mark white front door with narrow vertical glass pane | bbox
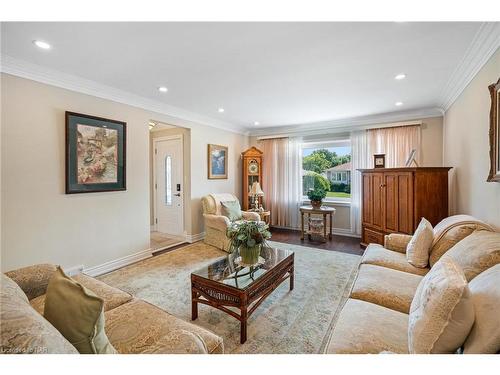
[153,136,184,236]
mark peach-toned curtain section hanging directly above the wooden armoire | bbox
[368,125,421,168]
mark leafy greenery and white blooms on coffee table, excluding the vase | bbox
[226,221,271,252]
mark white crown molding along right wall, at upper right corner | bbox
[439,22,500,111]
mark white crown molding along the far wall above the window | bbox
[250,108,444,137]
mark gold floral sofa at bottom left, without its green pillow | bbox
[0,264,224,354]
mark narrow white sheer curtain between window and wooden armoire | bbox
[351,130,373,235]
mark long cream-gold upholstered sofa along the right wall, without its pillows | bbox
[326,215,500,354]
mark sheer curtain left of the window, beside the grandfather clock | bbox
[259,138,302,228]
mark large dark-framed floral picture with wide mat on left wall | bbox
[65,111,127,194]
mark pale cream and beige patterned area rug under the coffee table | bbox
[99,242,360,354]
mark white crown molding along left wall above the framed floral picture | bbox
[0,55,248,135]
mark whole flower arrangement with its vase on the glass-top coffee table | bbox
[226,221,271,265]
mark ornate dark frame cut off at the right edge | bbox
[486,78,500,182]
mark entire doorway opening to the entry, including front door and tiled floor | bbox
[150,125,185,252]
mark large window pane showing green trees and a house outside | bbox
[302,140,351,201]
